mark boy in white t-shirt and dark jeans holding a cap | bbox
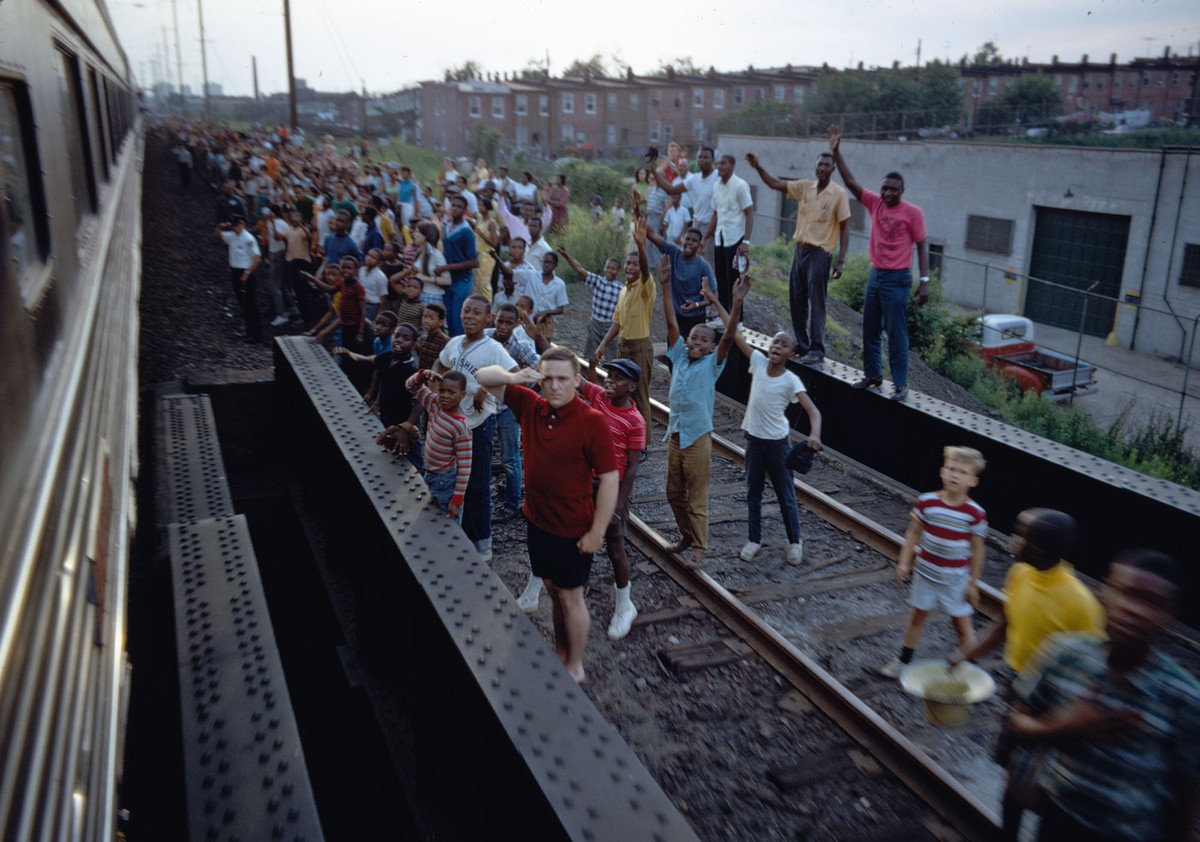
[734,319,821,565]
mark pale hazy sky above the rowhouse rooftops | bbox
[108,0,1200,95]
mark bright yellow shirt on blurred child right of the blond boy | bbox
[1004,561,1104,672]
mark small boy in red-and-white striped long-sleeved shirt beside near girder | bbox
[404,368,472,523]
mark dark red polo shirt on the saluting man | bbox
[504,386,617,539]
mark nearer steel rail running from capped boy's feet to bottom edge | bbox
[629,515,1000,841]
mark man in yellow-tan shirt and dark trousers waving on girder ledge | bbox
[746,152,850,366]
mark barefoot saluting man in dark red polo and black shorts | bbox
[475,347,619,684]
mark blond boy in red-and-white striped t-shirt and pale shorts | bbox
[880,445,988,678]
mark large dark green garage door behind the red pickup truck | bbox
[1025,208,1129,336]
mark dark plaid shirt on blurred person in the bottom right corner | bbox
[1013,632,1200,840]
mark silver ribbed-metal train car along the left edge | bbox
[0,0,142,840]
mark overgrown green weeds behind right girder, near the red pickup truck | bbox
[830,257,1200,489]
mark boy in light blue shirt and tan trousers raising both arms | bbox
[659,260,750,569]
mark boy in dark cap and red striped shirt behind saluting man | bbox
[517,359,646,640]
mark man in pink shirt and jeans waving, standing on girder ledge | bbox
[829,126,929,401]
